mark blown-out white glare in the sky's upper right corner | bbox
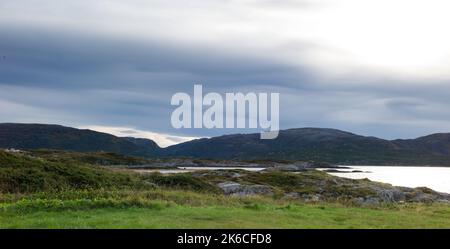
[304,0,450,79]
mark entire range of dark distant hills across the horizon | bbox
[0,123,450,166]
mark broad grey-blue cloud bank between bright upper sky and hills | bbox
[0,4,450,141]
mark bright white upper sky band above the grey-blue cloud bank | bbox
[0,0,450,80]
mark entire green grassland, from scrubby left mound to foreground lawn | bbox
[0,151,450,228]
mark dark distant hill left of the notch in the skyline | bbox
[0,123,160,157]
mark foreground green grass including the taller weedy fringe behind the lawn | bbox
[0,190,450,228]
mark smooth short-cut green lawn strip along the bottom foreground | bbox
[0,199,450,228]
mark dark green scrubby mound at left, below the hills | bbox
[0,151,145,193]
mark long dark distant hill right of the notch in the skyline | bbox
[163,128,450,165]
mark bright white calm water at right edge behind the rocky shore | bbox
[330,166,450,193]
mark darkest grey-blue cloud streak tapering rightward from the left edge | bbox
[0,27,304,89]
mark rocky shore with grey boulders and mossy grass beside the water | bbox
[192,167,450,205]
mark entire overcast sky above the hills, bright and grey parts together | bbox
[0,0,450,146]
